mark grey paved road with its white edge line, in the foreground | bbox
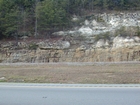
[0,83,140,105]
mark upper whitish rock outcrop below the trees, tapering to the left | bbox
[54,12,140,37]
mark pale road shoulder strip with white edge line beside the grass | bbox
[0,83,140,88]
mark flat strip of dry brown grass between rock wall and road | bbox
[0,64,140,84]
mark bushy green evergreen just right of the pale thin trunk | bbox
[37,0,68,34]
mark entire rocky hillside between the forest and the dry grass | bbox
[0,12,140,63]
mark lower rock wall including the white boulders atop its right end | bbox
[0,36,140,63]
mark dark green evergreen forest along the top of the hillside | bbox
[0,0,140,39]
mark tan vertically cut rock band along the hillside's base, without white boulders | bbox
[0,46,140,63]
